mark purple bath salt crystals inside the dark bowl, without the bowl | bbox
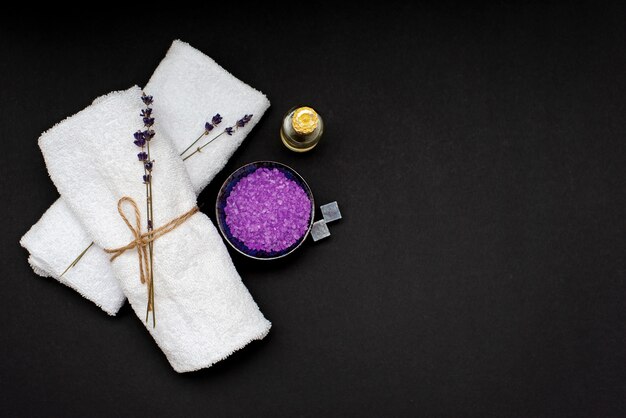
[224,168,311,252]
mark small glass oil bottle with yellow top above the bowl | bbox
[280,106,324,152]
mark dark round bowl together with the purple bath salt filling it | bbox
[216,161,315,260]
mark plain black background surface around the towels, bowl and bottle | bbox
[0,3,626,417]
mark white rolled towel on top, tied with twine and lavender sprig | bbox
[39,87,271,372]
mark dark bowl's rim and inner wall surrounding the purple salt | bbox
[215,161,315,260]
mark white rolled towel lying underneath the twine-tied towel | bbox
[20,41,269,315]
